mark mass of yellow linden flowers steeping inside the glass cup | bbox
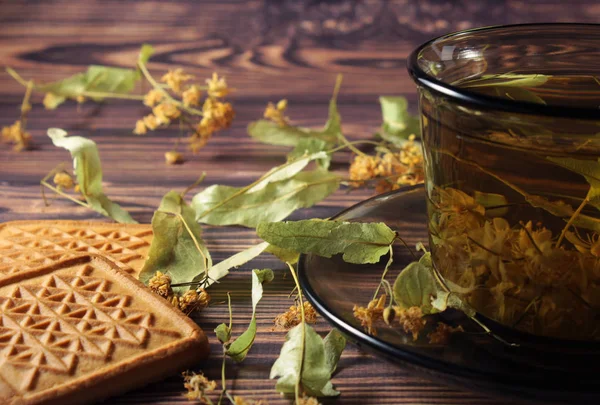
[429,187,600,339]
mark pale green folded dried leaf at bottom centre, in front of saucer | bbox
[270,323,346,397]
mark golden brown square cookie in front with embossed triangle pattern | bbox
[0,255,208,404]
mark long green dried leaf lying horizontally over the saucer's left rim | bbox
[256,219,396,263]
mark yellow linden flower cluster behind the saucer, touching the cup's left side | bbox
[349,135,425,193]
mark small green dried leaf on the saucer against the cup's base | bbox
[393,253,438,315]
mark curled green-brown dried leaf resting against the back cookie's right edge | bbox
[139,191,212,292]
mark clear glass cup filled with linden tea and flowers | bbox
[408,24,600,340]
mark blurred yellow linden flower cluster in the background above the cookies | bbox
[133,68,235,159]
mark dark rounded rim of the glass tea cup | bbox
[406,23,600,120]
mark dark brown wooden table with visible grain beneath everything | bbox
[0,0,600,404]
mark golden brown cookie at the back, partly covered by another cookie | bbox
[0,220,152,279]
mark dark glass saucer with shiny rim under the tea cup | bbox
[298,185,600,404]
